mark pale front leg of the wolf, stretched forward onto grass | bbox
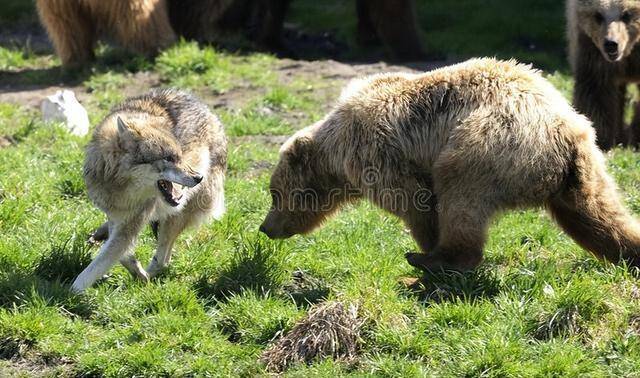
[71,216,144,293]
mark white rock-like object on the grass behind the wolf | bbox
[40,89,89,136]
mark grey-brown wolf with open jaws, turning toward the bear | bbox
[71,89,227,292]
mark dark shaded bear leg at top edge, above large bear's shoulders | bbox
[356,0,426,61]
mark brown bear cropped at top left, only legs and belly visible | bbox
[36,0,176,67]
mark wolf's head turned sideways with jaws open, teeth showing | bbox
[116,116,202,207]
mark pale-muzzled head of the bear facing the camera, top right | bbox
[576,0,640,62]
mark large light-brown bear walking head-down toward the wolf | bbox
[260,59,640,270]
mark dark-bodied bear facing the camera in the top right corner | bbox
[567,0,640,150]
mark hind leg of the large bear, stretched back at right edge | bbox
[547,128,640,266]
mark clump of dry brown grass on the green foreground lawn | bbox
[260,302,363,372]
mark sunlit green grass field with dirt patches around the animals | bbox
[0,0,640,377]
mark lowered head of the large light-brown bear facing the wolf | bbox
[260,126,344,239]
